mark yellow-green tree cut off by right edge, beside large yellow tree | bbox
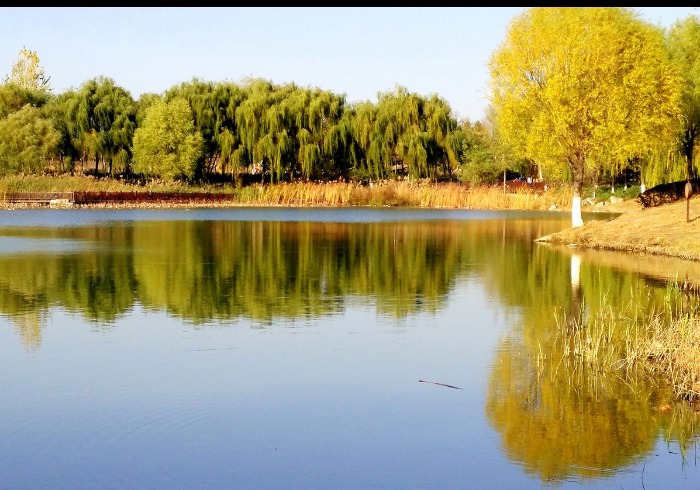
[667,15,700,184]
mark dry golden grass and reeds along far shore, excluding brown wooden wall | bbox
[0,176,572,210]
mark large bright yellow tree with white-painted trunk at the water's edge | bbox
[489,7,681,227]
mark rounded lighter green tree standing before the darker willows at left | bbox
[133,97,204,180]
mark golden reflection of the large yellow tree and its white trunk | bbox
[486,247,697,483]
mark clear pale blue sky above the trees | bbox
[0,7,700,121]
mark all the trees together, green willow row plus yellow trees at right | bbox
[5,7,700,196]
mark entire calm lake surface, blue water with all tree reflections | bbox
[0,208,700,490]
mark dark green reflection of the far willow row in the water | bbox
[0,212,572,324]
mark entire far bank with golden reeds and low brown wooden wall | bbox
[0,176,634,213]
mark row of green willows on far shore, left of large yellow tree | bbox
[0,71,512,188]
